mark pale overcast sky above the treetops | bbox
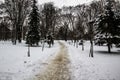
[0,0,92,7]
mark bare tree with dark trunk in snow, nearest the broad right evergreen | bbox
[87,2,99,57]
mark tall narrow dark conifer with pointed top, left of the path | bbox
[26,0,40,46]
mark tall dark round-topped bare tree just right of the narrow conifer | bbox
[42,2,56,38]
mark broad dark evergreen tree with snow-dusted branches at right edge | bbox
[98,0,120,53]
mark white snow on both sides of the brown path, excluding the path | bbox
[0,41,120,80]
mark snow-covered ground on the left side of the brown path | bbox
[0,42,59,80]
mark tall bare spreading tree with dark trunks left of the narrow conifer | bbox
[5,0,31,44]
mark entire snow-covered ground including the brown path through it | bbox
[0,41,120,80]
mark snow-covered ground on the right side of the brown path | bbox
[66,41,120,80]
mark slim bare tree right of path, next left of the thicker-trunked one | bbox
[76,4,87,50]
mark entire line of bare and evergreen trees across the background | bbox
[1,0,120,57]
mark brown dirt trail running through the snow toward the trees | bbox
[34,42,70,80]
